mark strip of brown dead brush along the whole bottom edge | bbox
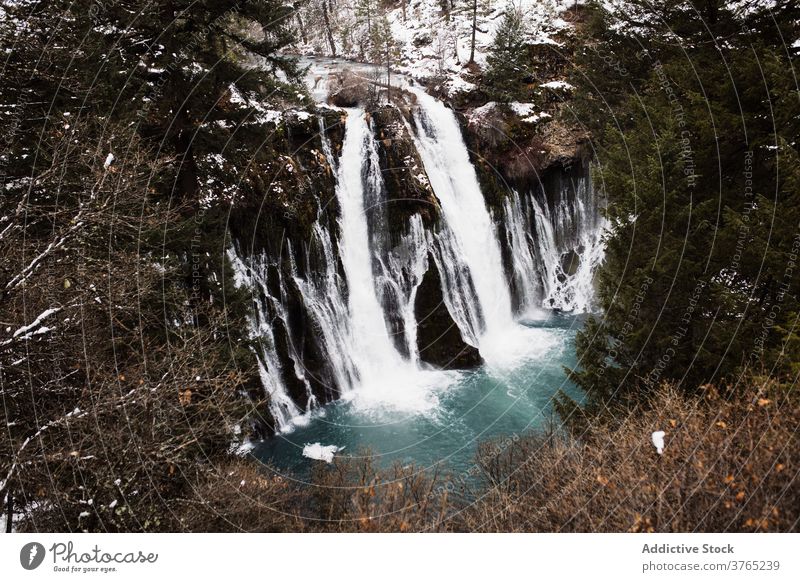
[17,380,788,532]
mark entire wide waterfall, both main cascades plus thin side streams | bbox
[238,74,604,432]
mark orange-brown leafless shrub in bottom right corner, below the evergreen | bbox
[458,383,800,532]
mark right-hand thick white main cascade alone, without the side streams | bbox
[411,88,513,349]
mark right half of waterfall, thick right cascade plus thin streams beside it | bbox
[409,87,603,368]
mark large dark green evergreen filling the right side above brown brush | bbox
[560,2,800,422]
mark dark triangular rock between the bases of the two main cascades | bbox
[414,256,483,369]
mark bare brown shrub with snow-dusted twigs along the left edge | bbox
[0,122,258,531]
